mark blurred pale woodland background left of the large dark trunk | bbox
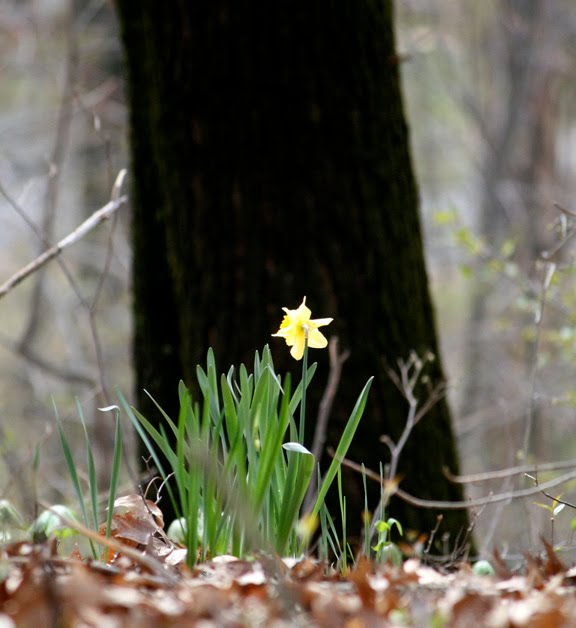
[0,0,132,513]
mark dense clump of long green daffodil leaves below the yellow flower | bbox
[120,347,372,565]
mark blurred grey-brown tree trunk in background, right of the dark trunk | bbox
[460,0,561,464]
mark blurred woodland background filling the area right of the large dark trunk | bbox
[398,0,576,547]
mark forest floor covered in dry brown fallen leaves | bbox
[0,538,576,628]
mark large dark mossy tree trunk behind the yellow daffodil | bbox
[117,0,468,548]
